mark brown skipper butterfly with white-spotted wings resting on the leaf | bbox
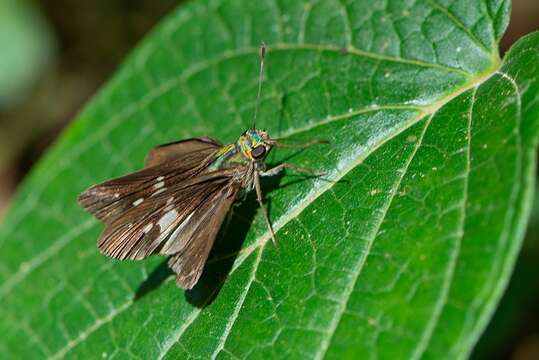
[79,45,326,289]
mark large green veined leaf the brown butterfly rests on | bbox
[0,0,539,359]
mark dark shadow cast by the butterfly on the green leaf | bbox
[134,170,284,308]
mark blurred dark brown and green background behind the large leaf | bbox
[0,0,539,360]
